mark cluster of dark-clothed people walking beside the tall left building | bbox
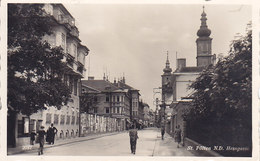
[30,124,58,155]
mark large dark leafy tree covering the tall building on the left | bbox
[8,4,70,116]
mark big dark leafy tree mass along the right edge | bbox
[183,23,252,155]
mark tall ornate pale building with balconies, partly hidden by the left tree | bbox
[8,4,89,146]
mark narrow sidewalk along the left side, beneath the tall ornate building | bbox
[7,131,127,155]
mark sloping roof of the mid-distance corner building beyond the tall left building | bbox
[82,80,123,92]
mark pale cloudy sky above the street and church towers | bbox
[64,4,251,109]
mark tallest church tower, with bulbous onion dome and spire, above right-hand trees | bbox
[196,6,215,67]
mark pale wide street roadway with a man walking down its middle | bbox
[14,128,192,156]
